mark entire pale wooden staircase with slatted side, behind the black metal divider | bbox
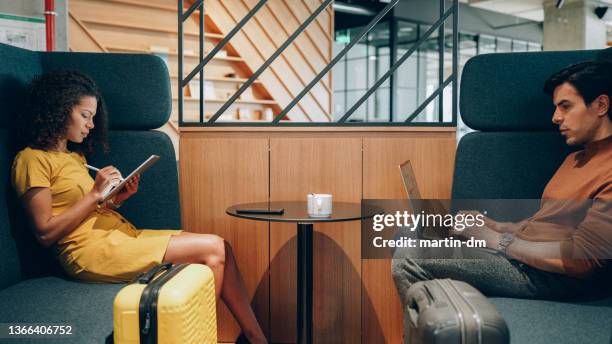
[68,0,333,153]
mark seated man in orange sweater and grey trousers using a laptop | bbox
[393,61,612,304]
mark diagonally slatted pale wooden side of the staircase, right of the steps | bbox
[205,0,333,122]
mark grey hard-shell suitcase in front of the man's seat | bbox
[404,279,510,344]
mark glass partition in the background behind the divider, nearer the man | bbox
[333,19,542,129]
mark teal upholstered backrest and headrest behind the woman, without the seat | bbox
[0,44,181,289]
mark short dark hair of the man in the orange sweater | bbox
[544,60,612,120]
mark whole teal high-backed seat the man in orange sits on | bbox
[452,49,612,344]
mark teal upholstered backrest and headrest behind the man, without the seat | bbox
[452,49,612,199]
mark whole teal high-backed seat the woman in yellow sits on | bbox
[0,44,181,343]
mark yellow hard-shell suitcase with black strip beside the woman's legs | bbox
[113,263,217,344]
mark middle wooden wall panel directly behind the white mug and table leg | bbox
[270,134,361,343]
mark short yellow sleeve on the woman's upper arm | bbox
[11,148,51,197]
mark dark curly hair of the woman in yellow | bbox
[17,71,108,154]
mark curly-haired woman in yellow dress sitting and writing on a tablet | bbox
[12,71,266,343]
